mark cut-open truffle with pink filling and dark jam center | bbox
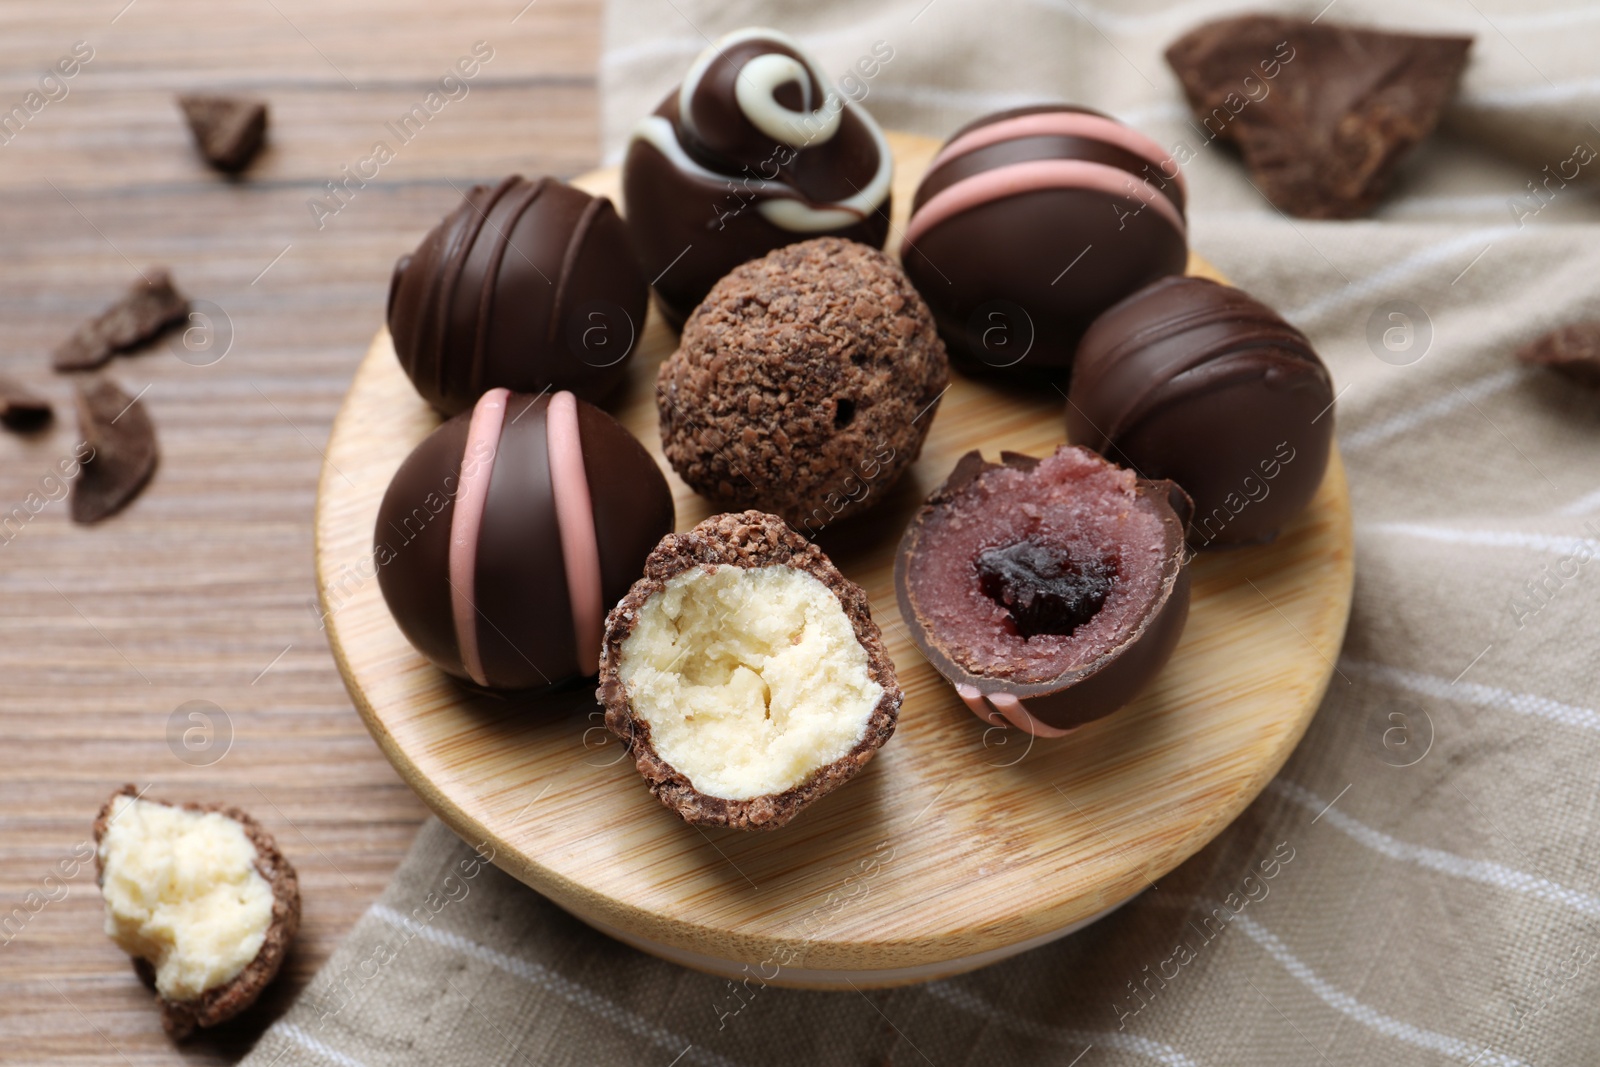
[894,445,1189,737]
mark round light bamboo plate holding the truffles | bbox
[315,136,1354,987]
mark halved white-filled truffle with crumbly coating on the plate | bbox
[598,512,901,830]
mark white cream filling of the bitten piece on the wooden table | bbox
[99,795,272,1001]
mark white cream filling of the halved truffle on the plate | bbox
[621,565,883,800]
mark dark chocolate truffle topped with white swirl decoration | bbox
[622,27,894,323]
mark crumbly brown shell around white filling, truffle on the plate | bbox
[595,510,901,830]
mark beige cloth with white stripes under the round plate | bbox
[246,0,1600,1067]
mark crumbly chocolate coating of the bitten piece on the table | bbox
[94,785,301,1041]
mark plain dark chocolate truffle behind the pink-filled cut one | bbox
[1067,278,1333,549]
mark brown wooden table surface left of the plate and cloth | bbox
[0,0,598,1067]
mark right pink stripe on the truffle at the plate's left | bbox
[544,392,605,673]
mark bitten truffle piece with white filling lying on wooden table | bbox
[94,785,301,1041]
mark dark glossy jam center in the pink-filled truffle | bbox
[976,541,1117,637]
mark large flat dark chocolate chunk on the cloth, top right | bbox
[1166,14,1472,219]
